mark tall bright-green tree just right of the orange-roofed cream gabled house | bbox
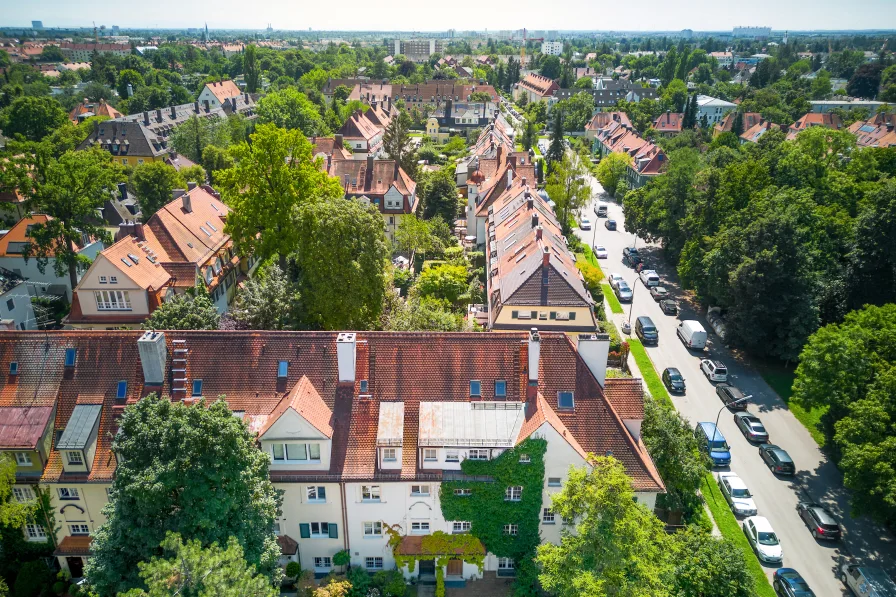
[215,124,344,268]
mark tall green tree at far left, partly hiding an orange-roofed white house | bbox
[22,147,124,288]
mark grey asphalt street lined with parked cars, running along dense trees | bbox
[576,176,896,597]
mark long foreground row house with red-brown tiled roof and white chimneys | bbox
[0,329,664,583]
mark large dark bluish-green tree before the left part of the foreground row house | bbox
[85,394,282,596]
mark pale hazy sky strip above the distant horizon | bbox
[0,0,896,31]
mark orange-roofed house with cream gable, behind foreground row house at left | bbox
[65,183,257,329]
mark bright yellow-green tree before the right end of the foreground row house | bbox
[536,456,672,597]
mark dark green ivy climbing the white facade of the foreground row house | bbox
[440,439,547,595]
